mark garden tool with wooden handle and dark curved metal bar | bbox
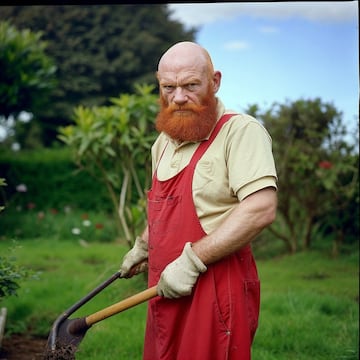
[44,272,157,360]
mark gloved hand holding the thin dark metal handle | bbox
[120,236,148,278]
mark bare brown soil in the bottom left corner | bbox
[0,334,47,360]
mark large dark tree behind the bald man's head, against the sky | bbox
[0,4,195,145]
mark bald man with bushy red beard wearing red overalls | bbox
[120,42,277,360]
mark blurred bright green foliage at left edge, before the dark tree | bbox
[0,21,56,119]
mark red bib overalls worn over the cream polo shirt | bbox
[143,115,260,360]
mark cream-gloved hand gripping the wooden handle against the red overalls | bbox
[157,242,207,299]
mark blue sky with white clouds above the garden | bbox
[169,1,359,134]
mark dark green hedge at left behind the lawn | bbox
[0,148,112,212]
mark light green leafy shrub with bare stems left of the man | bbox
[59,85,158,245]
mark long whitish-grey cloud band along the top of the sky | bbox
[169,0,358,27]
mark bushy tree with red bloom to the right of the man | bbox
[248,99,359,252]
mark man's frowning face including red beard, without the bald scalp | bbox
[156,66,217,142]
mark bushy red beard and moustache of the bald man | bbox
[156,93,217,142]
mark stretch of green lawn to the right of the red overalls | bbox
[253,252,359,360]
